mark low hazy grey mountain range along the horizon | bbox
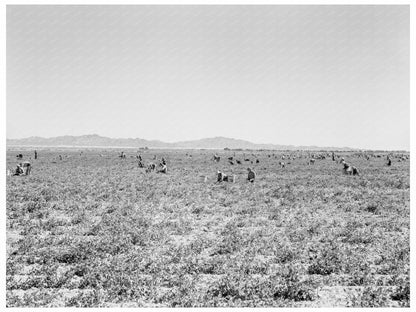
[6,134,354,150]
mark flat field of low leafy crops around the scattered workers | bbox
[6,149,410,307]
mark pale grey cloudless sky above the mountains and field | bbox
[6,5,410,149]
